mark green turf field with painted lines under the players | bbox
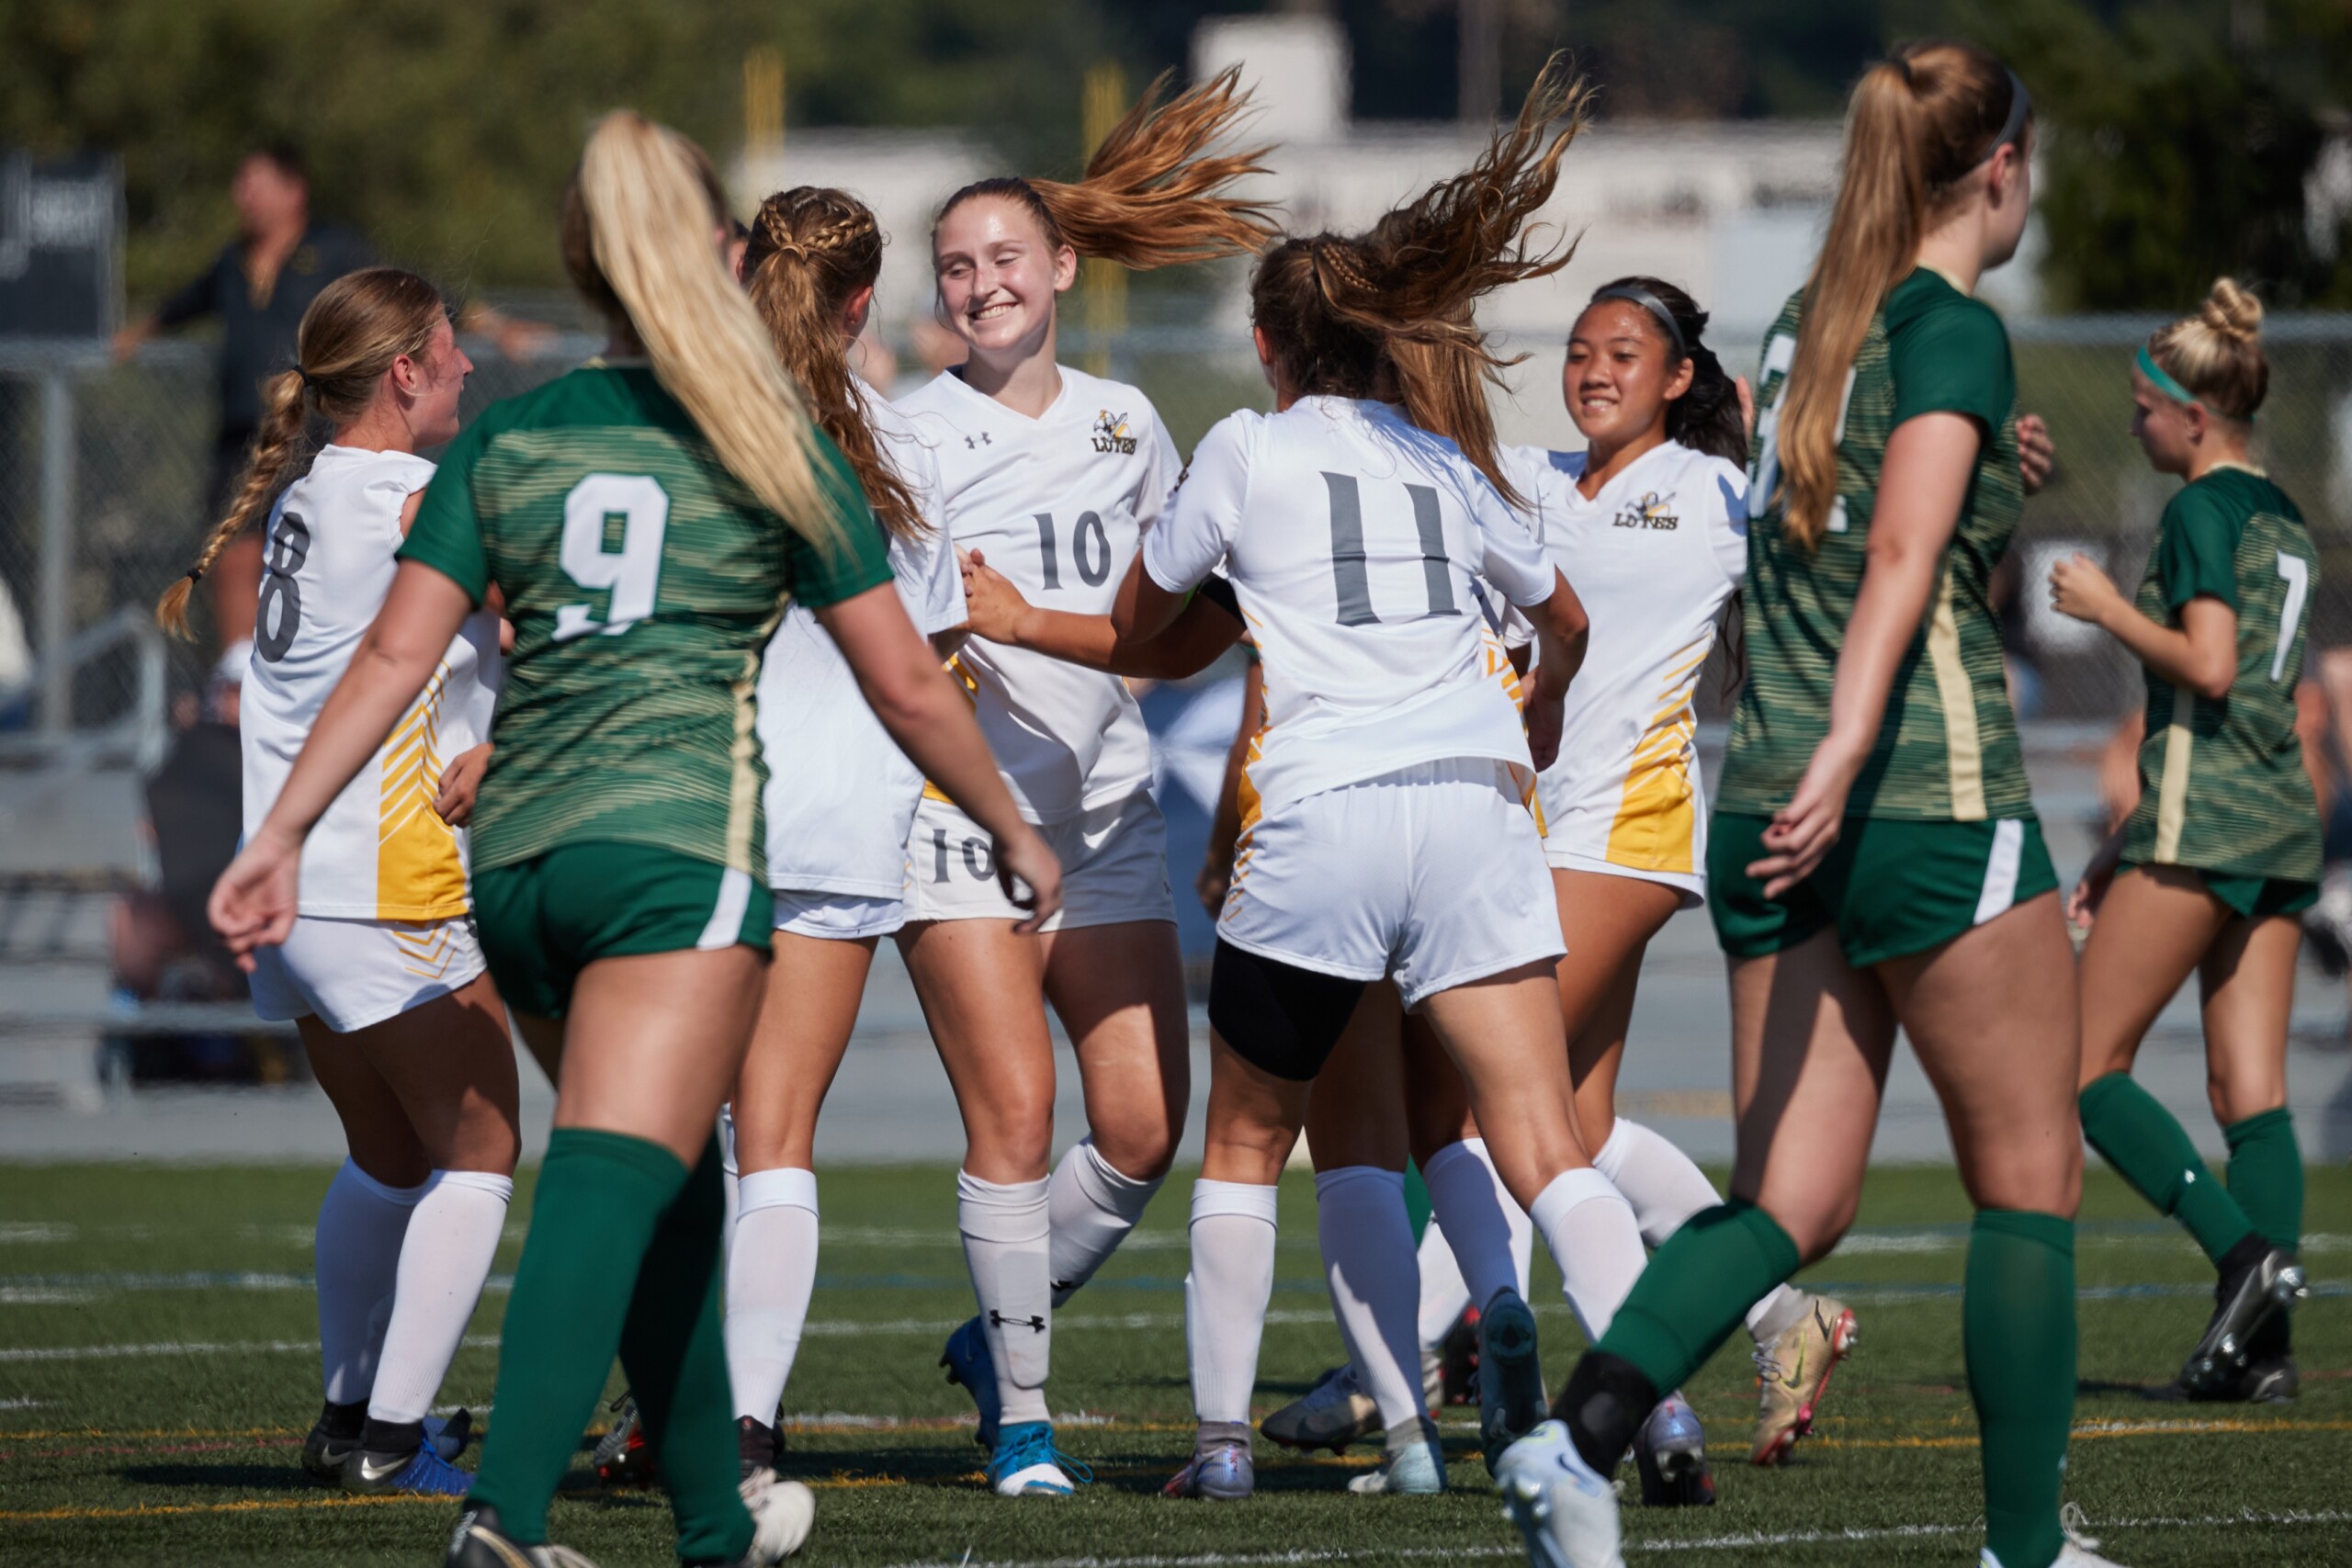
[0,1166,2352,1568]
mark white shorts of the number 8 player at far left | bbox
[252,915,484,1034]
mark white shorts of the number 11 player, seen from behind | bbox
[1216,757,1566,1009]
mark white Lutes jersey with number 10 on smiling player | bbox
[896,367,1179,823]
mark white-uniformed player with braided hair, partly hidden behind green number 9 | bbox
[727,186,965,1474]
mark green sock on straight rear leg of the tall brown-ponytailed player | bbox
[1962,1208,2075,1568]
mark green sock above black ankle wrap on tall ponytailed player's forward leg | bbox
[1592,1199,1797,1416]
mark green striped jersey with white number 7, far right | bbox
[2124,468,2319,882]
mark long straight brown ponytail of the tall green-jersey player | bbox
[1755,42,2025,550]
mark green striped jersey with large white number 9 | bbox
[400,365,891,877]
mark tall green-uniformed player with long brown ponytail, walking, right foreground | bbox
[1510,42,2135,1568]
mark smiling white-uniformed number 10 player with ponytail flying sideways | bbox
[899,73,1268,1495]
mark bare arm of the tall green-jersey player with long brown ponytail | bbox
[1747,412,1983,898]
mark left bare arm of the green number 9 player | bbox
[205,562,473,971]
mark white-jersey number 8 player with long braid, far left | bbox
[158,268,517,1497]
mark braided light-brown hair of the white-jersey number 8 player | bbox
[155,265,449,637]
